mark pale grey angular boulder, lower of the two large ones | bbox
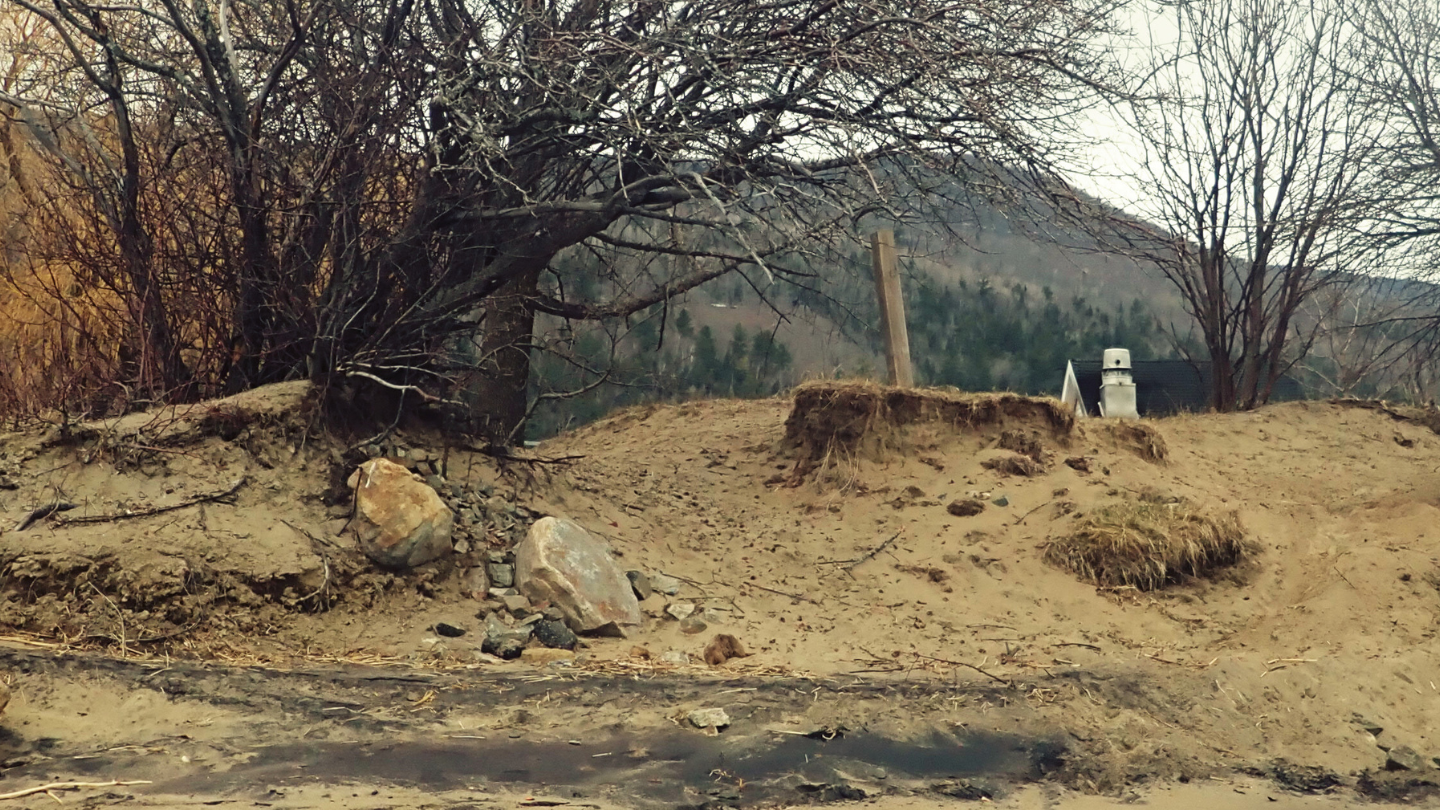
[516,517,641,634]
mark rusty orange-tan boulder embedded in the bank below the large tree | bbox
[348,458,455,568]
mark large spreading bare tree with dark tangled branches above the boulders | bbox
[7,0,1116,442]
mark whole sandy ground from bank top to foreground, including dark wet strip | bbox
[0,385,1440,810]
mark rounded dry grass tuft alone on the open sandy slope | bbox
[1045,502,1254,591]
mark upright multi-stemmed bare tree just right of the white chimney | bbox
[1126,0,1378,411]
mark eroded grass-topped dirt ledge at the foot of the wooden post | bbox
[785,380,1074,484]
